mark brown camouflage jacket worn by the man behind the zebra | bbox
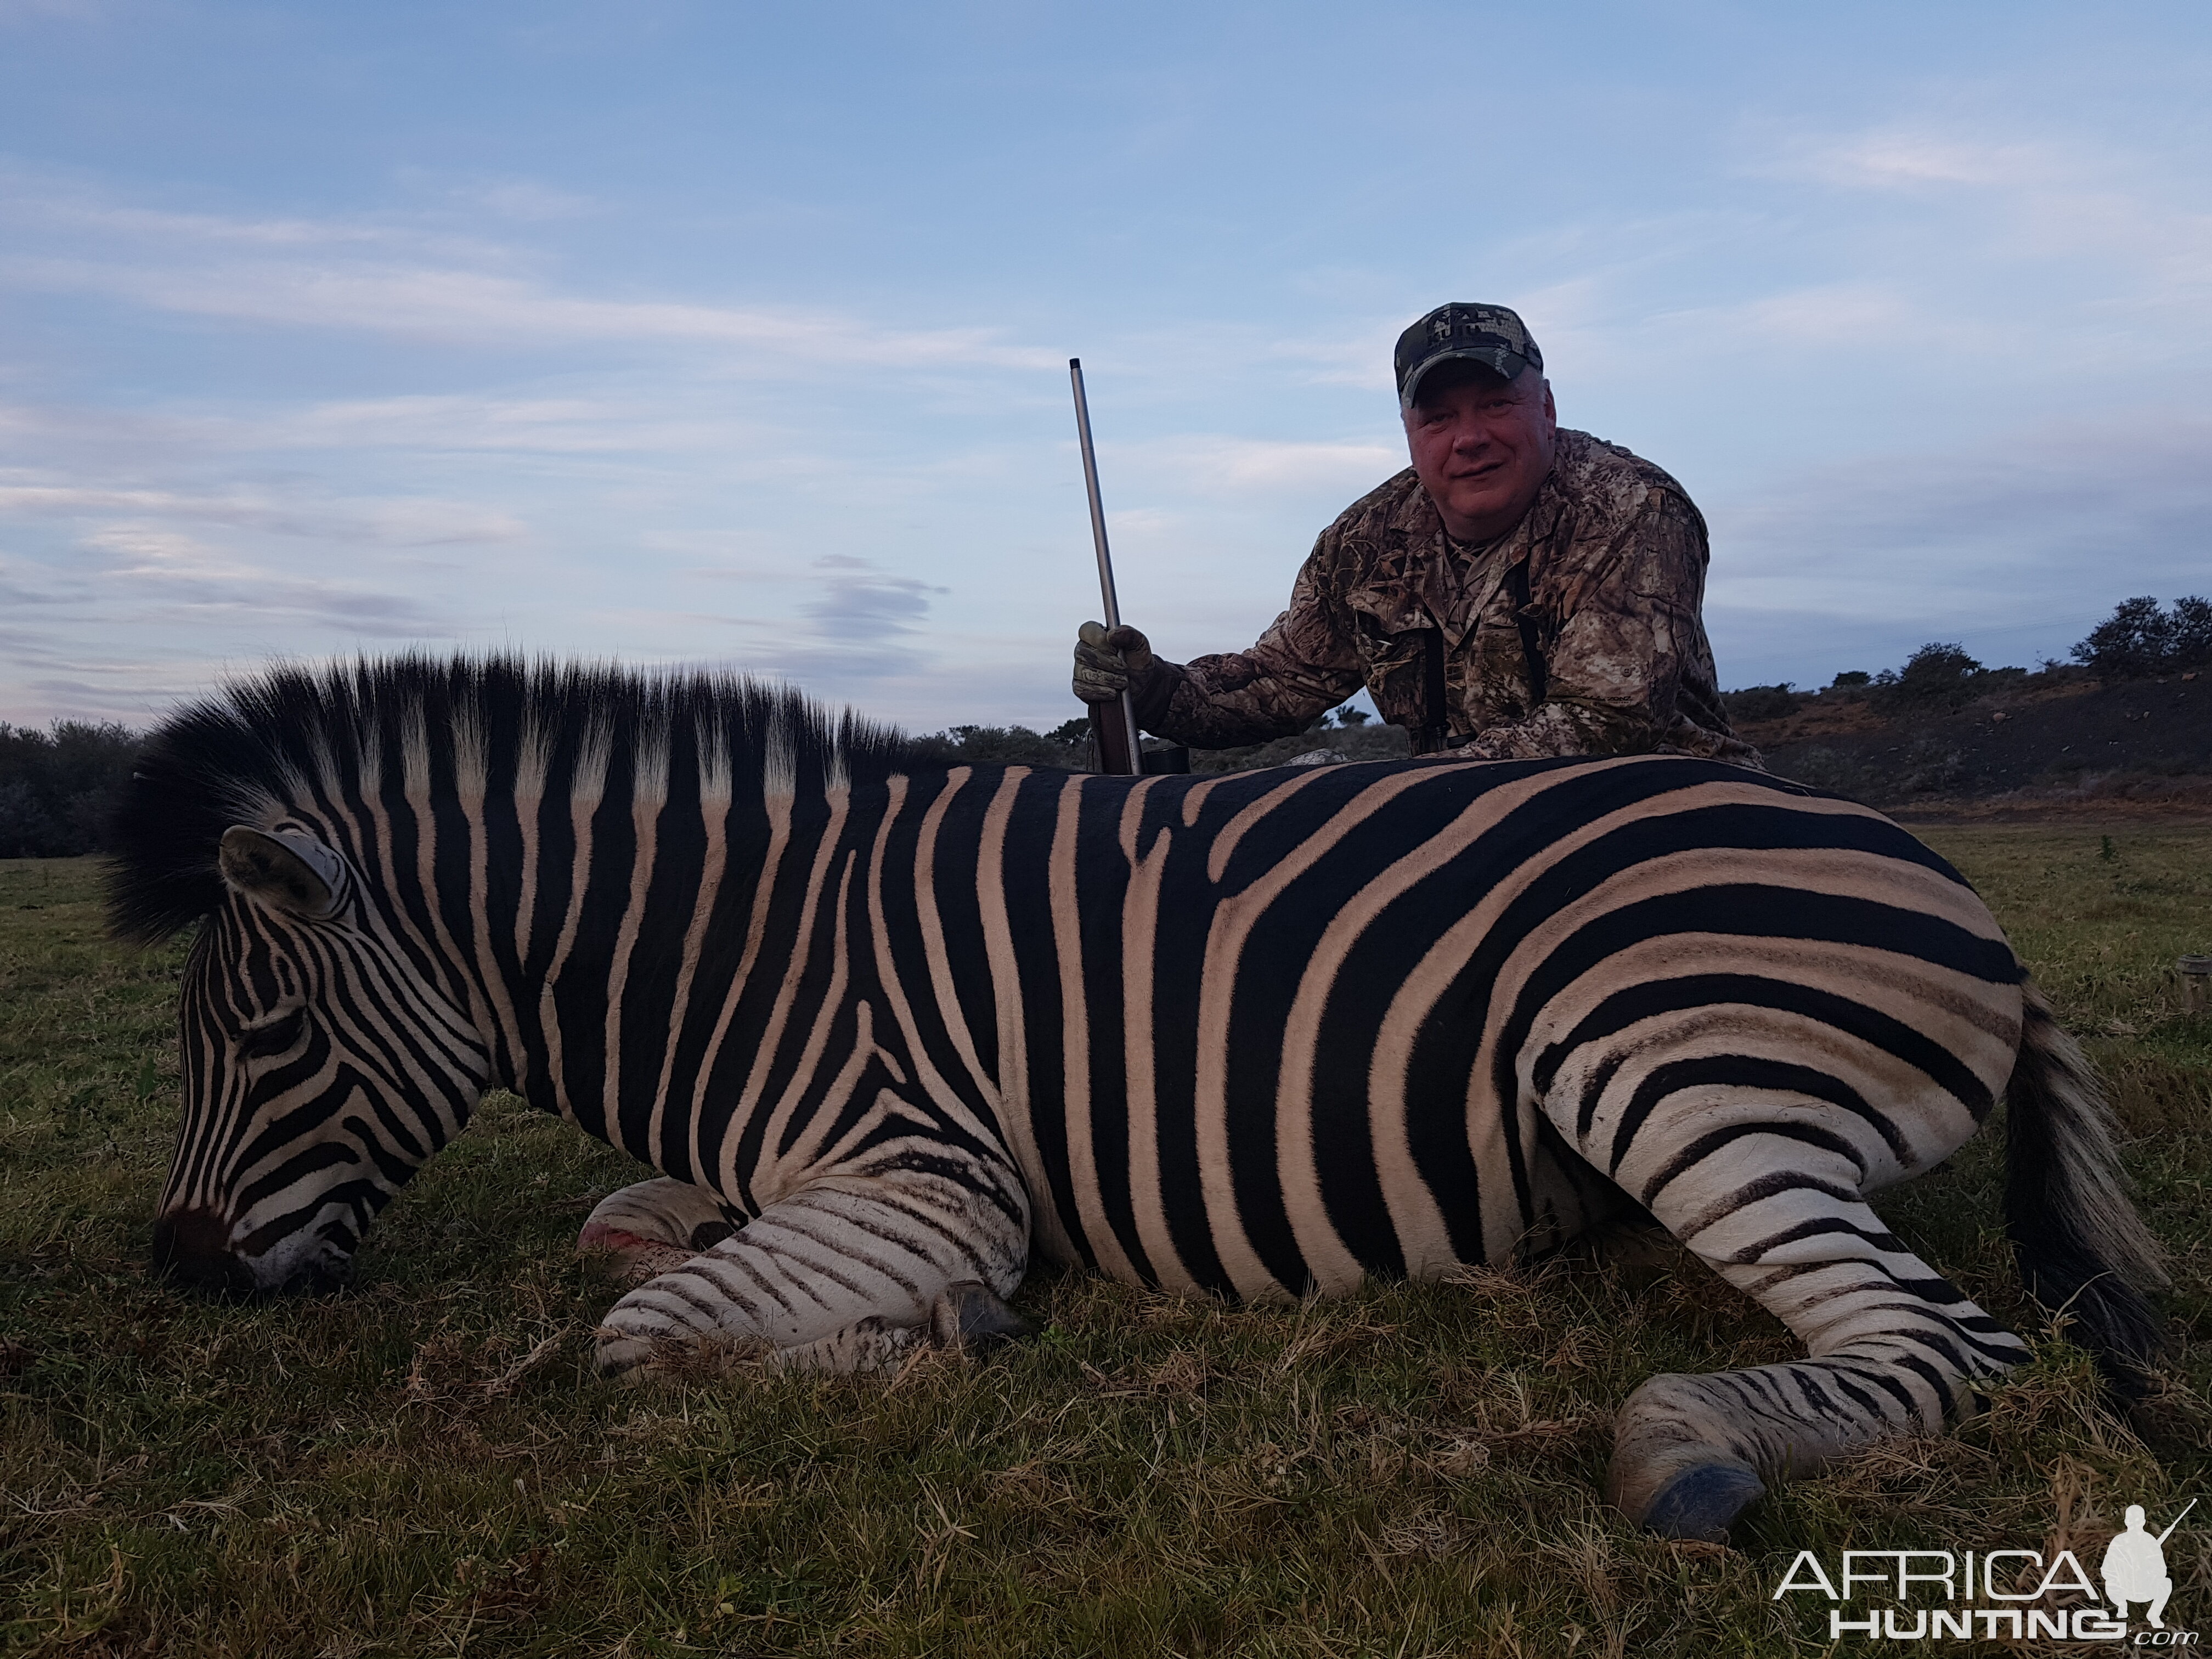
[1130,429,1758,765]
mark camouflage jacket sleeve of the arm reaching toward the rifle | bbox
[1137,535,1363,750]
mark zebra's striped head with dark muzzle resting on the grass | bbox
[155,823,491,1294]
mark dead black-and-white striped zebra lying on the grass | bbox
[111,657,2161,1539]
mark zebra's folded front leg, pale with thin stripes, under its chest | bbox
[597,1148,1029,1376]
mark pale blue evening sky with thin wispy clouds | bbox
[0,0,2212,730]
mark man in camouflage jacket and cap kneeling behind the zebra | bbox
[1075,305,1758,765]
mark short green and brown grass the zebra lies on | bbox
[0,825,2212,1659]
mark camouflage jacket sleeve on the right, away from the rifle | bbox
[1460,491,1708,761]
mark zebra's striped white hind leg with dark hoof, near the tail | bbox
[1586,1093,2026,1542]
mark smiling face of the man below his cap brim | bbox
[1404,363,1560,542]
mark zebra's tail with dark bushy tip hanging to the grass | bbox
[2004,984,2168,1398]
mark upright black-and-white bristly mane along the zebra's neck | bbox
[109,654,909,945]
